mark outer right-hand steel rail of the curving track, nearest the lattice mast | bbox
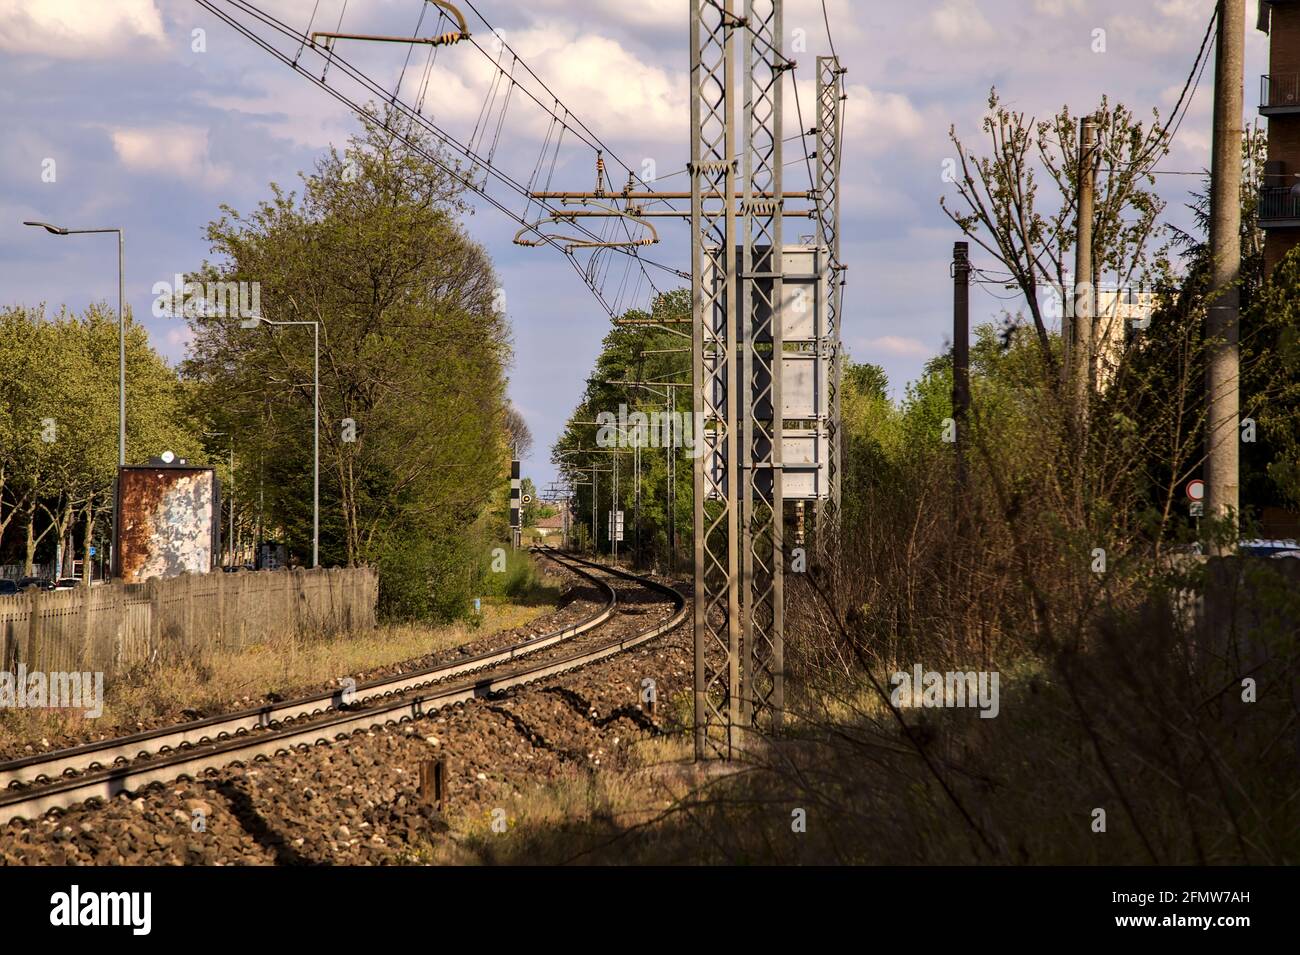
[0,548,688,824]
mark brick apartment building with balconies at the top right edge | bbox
[1258,0,1300,273]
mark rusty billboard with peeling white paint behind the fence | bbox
[113,464,221,583]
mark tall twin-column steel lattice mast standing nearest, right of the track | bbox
[690,0,792,758]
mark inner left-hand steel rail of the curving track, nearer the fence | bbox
[0,561,618,787]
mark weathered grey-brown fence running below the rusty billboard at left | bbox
[0,568,378,677]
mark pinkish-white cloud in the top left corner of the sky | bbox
[0,0,164,58]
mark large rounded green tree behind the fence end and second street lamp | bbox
[185,106,512,616]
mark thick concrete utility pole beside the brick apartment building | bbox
[1205,0,1245,540]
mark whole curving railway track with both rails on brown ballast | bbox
[0,548,688,824]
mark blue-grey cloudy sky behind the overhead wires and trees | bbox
[0,0,1266,482]
